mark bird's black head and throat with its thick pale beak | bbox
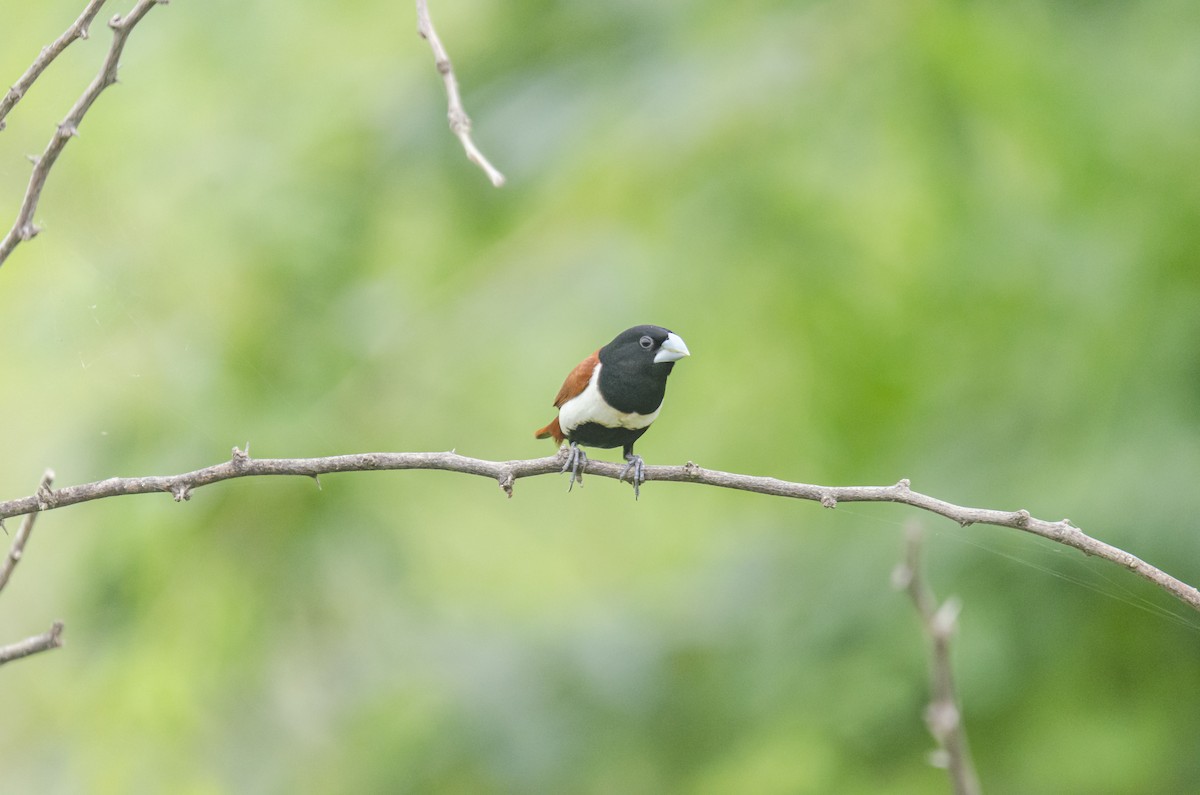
[600,325,690,414]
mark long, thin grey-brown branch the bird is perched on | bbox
[0,448,1200,611]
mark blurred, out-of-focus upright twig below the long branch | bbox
[892,527,980,795]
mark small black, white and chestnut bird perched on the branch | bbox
[534,325,690,500]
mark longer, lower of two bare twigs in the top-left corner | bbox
[0,0,167,265]
